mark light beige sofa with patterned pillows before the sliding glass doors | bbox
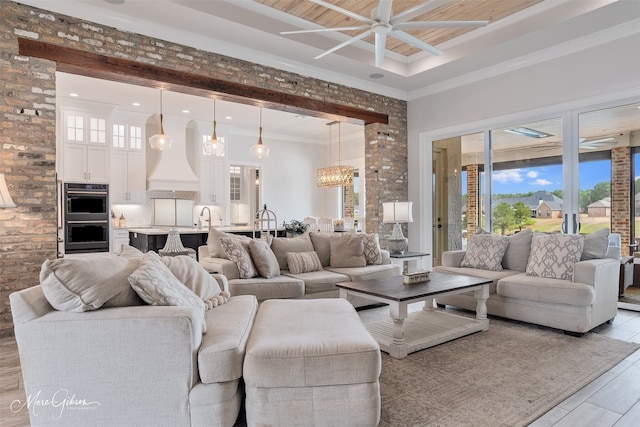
[435,229,620,334]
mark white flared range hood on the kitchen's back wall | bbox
[147,117,200,191]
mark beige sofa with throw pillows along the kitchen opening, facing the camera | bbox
[198,228,401,306]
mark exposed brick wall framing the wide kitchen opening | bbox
[0,0,407,336]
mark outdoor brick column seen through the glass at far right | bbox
[611,147,632,249]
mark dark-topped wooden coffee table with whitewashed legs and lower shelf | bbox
[337,272,491,359]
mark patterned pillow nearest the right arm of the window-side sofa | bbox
[526,233,584,280]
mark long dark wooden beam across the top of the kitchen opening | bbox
[18,37,389,125]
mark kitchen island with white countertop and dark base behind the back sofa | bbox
[128,225,284,254]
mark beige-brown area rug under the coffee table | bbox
[360,307,640,427]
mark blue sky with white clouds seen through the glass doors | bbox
[463,160,611,194]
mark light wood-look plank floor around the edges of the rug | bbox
[0,310,640,427]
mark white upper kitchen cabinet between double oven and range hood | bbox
[110,149,146,204]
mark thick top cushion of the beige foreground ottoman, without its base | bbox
[244,298,381,388]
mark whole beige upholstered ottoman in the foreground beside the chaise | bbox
[243,298,381,426]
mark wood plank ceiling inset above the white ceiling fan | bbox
[255,0,542,56]
